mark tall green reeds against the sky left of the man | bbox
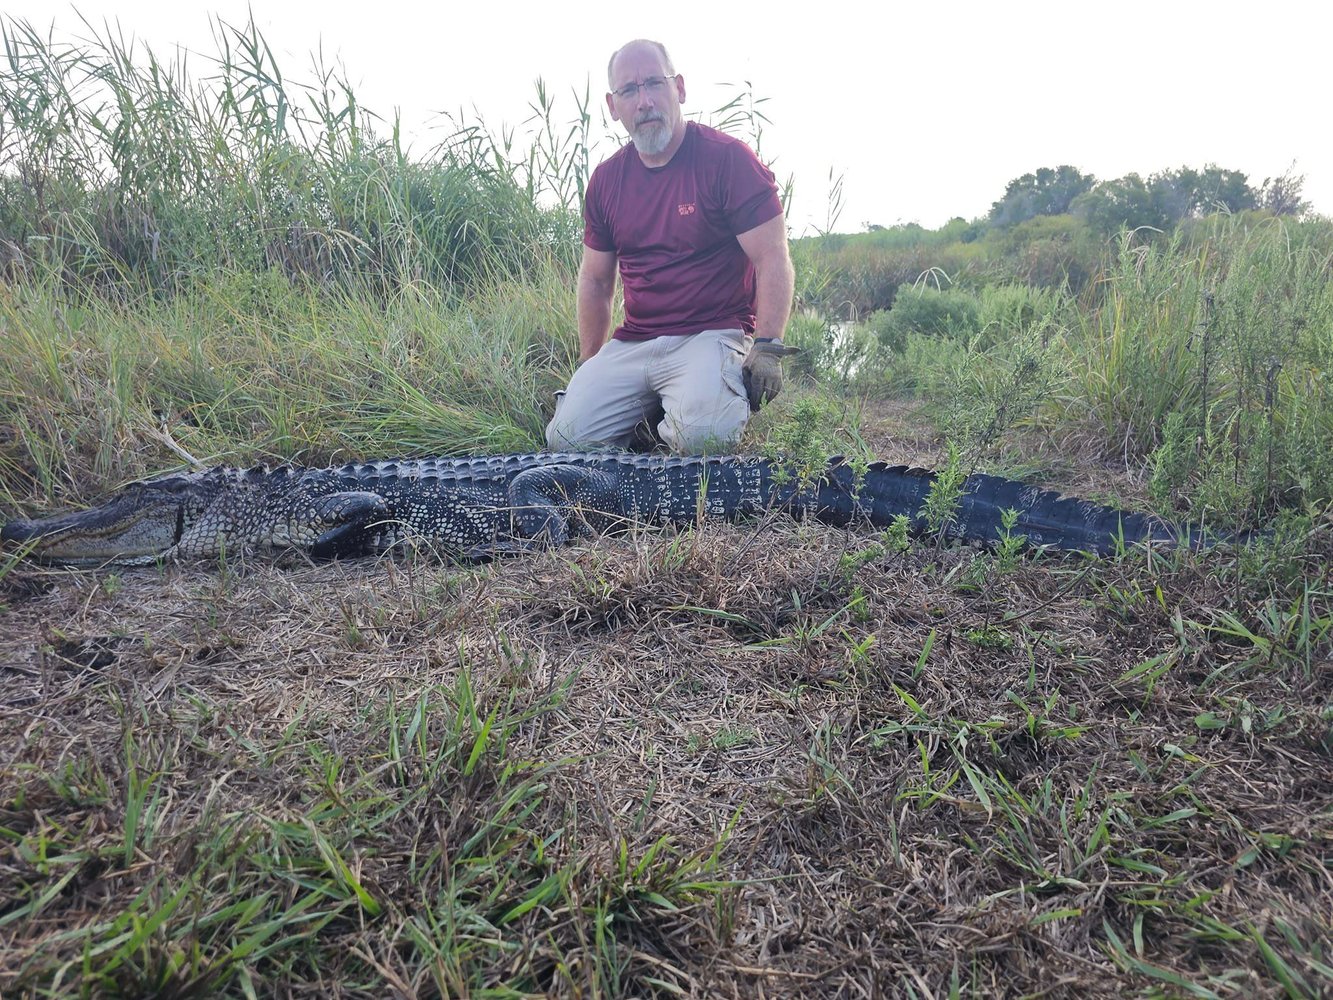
[0,19,587,296]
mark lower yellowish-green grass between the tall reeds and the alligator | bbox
[0,267,575,505]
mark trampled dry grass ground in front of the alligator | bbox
[0,416,1333,997]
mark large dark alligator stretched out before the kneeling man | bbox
[0,452,1206,567]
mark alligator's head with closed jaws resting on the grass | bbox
[0,472,219,565]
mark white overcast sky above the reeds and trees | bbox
[0,0,1333,236]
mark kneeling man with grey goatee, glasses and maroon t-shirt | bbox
[547,40,794,455]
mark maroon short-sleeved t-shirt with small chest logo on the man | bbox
[584,121,782,340]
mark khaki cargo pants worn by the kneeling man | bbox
[547,329,752,455]
